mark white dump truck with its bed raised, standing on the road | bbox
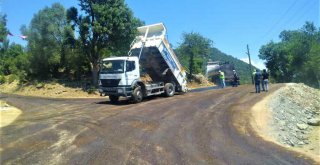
[99,23,187,103]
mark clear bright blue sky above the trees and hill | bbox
[0,0,320,69]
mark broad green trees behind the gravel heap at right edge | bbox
[259,22,320,88]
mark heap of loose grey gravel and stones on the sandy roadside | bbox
[269,84,320,147]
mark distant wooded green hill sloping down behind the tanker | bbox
[209,48,255,84]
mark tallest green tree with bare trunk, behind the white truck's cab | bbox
[67,0,142,85]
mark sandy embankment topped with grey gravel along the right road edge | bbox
[252,84,320,162]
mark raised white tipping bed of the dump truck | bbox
[129,23,187,92]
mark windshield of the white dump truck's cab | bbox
[100,60,124,73]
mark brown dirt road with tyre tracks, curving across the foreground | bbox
[0,85,314,165]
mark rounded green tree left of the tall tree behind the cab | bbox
[26,3,68,78]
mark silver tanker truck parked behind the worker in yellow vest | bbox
[206,61,235,84]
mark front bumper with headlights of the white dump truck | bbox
[99,86,132,97]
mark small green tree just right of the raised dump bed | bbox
[176,32,212,79]
